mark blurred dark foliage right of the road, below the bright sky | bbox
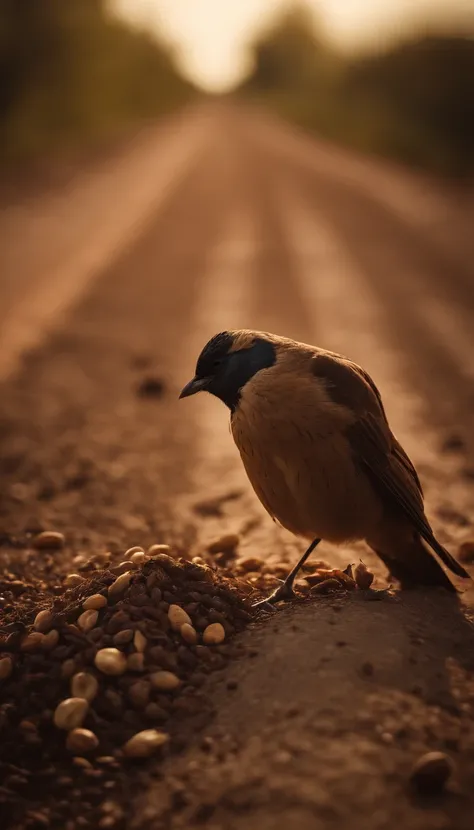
[241,10,474,177]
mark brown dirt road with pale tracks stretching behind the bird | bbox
[0,107,474,830]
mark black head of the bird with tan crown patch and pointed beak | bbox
[179,331,276,412]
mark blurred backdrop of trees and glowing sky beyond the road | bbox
[0,0,474,179]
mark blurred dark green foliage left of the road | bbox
[0,0,192,158]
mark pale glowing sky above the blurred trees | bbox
[111,0,474,90]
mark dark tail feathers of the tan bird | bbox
[376,534,469,593]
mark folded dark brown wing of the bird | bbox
[312,353,426,520]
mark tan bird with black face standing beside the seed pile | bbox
[179,329,469,604]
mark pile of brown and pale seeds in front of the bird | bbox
[0,546,251,827]
